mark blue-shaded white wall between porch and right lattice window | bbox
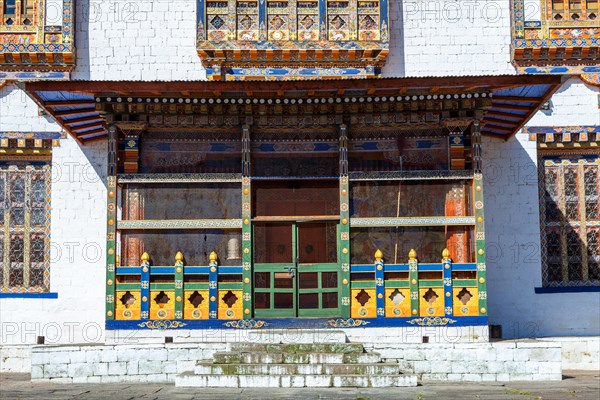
[482,131,600,338]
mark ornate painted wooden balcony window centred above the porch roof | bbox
[197,0,389,79]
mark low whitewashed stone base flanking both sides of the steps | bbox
[31,341,562,383]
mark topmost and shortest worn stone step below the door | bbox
[228,343,364,353]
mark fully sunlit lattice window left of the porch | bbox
[0,160,51,292]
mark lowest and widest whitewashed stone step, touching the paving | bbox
[175,372,417,388]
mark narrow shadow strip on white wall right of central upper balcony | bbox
[381,0,406,78]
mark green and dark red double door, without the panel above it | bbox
[253,218,340,318]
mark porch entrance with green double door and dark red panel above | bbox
[253,181,340,318]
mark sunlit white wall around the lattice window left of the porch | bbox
[0,85,106,345]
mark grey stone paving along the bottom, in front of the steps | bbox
[0,371,600,400]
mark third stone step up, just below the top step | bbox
[213,352,381,364]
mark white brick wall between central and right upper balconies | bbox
[383,0,515,77]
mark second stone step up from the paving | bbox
[194,363,400,375]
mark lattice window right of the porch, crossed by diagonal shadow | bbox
[540,155,600,287]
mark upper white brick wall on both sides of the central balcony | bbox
[72,0,514,81]
